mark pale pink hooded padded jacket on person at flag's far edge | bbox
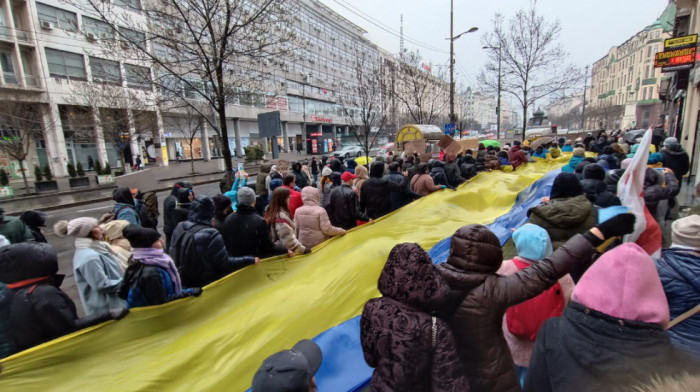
[294,186,345,248]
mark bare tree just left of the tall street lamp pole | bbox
[392,51,449,124]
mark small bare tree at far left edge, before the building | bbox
[0,101,50,194]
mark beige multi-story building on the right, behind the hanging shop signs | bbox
[586,2,676,129]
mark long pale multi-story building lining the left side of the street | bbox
[0,0,459,177]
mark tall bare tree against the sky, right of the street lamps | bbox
[479,2,583,138]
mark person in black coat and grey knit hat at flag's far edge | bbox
[223,188,294,259]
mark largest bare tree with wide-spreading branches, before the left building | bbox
[65,0,302,171]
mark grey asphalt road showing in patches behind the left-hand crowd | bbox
[43,179,230,317]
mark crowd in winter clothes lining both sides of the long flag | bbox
[0,131,700,391]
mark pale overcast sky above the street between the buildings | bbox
[320,0,668,90]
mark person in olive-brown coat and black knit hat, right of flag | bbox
[527,173,597,258]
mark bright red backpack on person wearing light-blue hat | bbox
[506,258,564,341]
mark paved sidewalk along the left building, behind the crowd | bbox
[0,153,311,215]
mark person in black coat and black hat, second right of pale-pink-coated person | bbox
[360,162,410,219]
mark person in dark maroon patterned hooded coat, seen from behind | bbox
[360,243,469,391]
